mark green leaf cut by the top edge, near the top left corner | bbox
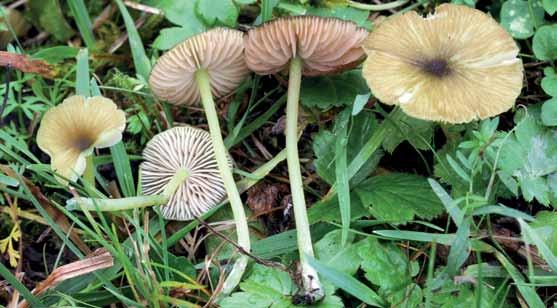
[27,0,74,42]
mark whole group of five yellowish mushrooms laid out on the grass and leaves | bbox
[37,4,523,300]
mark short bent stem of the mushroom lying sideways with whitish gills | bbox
[66,168,189,212]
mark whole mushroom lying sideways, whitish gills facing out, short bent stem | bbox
[68,126,225,220]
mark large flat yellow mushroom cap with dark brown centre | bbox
[363,4,523,123]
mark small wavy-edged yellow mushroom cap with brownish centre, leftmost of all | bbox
[37,95,126,184]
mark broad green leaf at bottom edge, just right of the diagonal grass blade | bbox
[358,237,421,306]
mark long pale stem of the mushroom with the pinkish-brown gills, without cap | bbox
[285,57,324,301]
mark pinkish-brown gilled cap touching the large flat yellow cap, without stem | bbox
[244,16,368,76]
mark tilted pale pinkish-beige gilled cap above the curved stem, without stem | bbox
[149,28,249,105]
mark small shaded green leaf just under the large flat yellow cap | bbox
[383,115,434,153]
